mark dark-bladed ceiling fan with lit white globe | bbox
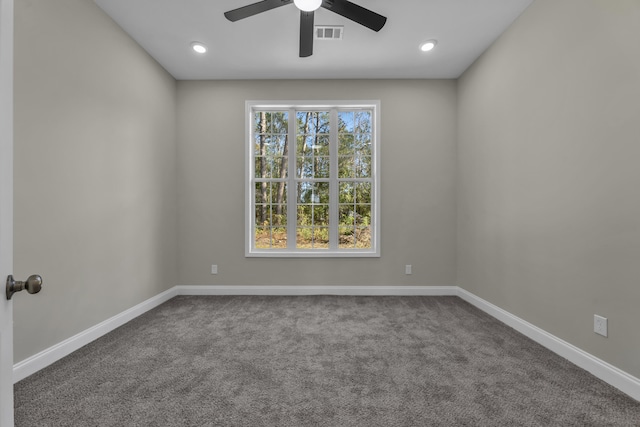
[224,0,387,58]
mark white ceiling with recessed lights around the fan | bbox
[95,0,532,80]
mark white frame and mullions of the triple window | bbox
[245,100,380,258]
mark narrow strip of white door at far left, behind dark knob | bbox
[0,0,14,427]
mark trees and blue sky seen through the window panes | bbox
[253,110,373,249]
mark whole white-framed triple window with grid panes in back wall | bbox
[246,101,380,257]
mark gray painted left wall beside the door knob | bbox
[14,0,177,362]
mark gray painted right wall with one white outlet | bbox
[458,0,640,377]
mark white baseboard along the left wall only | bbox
[13,287,178,384]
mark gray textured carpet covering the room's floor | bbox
[15,296,640,427]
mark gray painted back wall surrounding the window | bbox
[178,80,456,285]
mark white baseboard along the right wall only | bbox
[458,288,640,401]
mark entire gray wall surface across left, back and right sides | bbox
[14,0,640,384]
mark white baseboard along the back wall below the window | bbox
[176,286,458,296]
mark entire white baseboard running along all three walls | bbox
[13,286,640,401]
